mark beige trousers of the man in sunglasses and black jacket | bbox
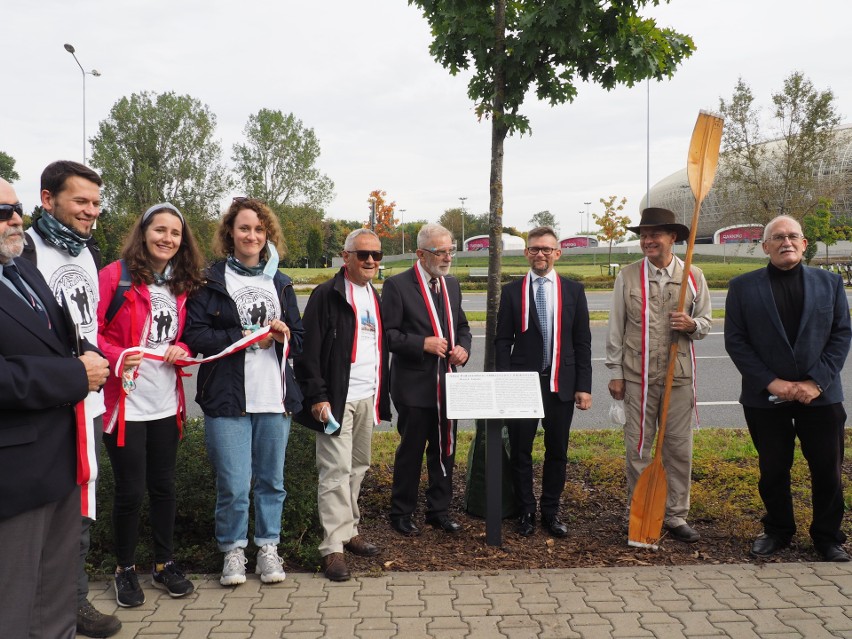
[316,397,374,557]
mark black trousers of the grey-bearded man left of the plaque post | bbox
[390,405,456,519]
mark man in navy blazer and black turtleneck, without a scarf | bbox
[725,215,852,561]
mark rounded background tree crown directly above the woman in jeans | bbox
[236,109,334,208]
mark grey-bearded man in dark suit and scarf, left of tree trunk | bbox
[382,224,471,536]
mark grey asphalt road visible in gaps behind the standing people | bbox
[184,314,852,430]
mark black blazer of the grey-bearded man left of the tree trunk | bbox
[382,265,472,408]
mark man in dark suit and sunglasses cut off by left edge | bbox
[0,180,109,639]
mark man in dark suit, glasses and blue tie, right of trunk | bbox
[494,226,592,537]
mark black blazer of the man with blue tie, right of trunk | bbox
[494,276,592,402]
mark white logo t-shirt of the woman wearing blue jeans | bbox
[225,267,284,413]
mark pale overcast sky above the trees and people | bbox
[0,0,852,235]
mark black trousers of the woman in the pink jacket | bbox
[104,417,179,567]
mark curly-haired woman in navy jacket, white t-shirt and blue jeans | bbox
[184,198,303,586]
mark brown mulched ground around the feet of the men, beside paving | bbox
[338,463,852,575]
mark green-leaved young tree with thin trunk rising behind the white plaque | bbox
[409,0,694,371]
